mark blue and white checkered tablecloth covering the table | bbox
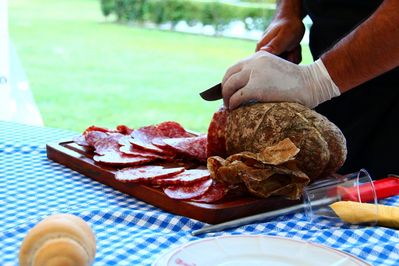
[0,122,399,265]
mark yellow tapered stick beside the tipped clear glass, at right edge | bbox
[330,201,399,228]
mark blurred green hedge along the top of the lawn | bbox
[100,0,274,32]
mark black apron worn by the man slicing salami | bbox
[304,0,399,179]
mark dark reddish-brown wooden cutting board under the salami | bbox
[46,140,299,224]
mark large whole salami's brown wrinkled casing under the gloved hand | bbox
[226,102,347,180]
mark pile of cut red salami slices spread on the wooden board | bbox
[74,121,227,202]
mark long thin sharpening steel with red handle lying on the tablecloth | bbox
[191,175,399,236]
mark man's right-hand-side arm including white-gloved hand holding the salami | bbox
[222,0,399,109]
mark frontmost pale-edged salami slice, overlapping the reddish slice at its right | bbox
[163,179,213,200]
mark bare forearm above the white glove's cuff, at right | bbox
[321,0,399,92]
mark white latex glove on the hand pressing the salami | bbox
[222,51,341,109]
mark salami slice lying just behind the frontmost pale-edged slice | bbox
[152,169,210,186]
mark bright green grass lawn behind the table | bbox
[9,0,316,132]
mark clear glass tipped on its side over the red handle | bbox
[303,169,378,223]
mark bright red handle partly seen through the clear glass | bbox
[337,176,399,202]
